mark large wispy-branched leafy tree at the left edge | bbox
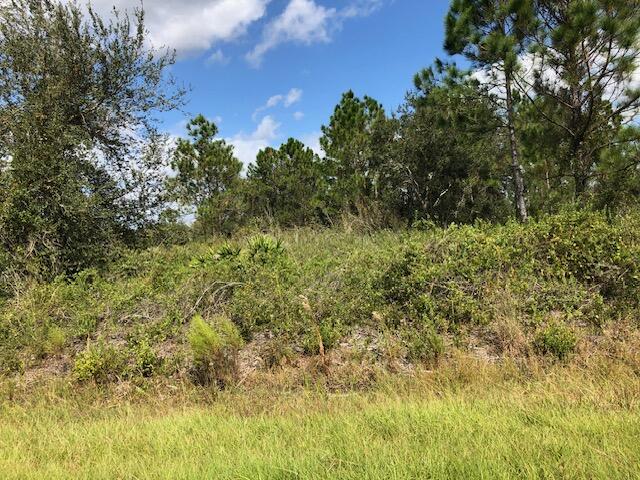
[0,0,181,279]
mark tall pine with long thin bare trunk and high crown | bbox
[445,0,535,222]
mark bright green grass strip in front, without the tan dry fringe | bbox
[0,376,640,480]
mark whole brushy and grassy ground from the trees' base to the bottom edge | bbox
[0,212,640,480]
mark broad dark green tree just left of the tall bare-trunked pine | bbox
[380,62,509,225]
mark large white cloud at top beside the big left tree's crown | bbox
[78,0,270,55]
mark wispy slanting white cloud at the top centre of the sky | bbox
[246,0,384,67]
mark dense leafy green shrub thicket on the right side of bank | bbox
[378,208,640,336]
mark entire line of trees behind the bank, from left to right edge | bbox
[0,0,640,283]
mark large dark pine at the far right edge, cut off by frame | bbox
[521,0,640,198]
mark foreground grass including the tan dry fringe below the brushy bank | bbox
[0,356,640,479]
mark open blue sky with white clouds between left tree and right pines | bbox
[93,0,449,163]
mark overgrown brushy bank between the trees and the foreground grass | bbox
[0,211,640,387]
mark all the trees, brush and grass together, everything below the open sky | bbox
[0,0,640,472]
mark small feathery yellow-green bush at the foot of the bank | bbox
[188,315,243,387]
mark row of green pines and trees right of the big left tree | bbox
[174,0,640,231]
